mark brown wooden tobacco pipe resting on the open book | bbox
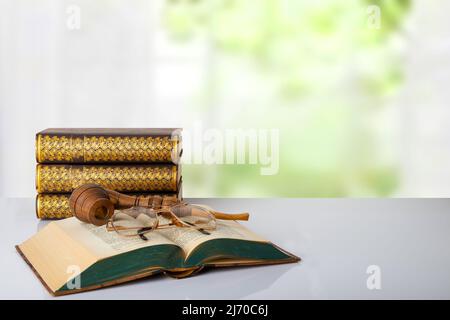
[69,183,249,226]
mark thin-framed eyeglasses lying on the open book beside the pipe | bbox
[106,202,249,240]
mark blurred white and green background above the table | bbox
[7,0,450,197]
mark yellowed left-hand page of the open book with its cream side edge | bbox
[19,218,174,292]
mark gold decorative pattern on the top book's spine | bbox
[36,134,178,163]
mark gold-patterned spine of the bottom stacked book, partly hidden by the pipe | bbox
[36,192,182,220]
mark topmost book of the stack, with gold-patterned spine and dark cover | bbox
[36,128,182,163]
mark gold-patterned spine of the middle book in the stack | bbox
[36,164,180,193]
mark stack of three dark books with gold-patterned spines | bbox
[36,129,182,219]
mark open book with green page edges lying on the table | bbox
[16,218,300,295]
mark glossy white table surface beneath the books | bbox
[0,198,450,299]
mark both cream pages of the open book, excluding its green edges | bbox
[18,218,269,293]
